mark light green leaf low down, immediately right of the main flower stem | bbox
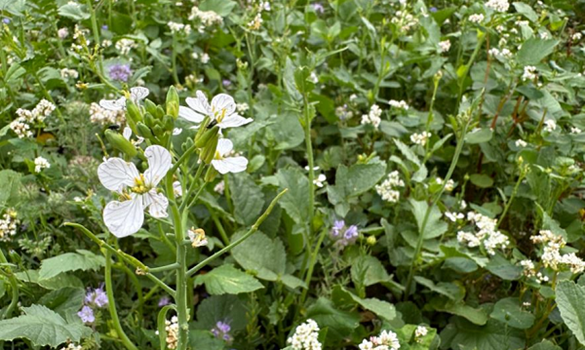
[195,264,264,295]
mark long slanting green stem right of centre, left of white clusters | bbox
[404,119,470,300]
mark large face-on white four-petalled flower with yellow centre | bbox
[98,145,172,238]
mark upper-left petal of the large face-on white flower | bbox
[98,157,140,192]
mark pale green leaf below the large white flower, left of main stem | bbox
[39,249,106,280]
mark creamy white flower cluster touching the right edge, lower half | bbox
[530,230,585,273]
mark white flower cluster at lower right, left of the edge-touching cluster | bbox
[457,211,510,255]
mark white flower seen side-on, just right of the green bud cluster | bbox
[179,91,252,129]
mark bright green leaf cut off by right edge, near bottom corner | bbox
[556,281,585,345]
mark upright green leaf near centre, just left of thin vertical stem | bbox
[276,168,310,225]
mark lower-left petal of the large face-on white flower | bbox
[104,195,144,238]
